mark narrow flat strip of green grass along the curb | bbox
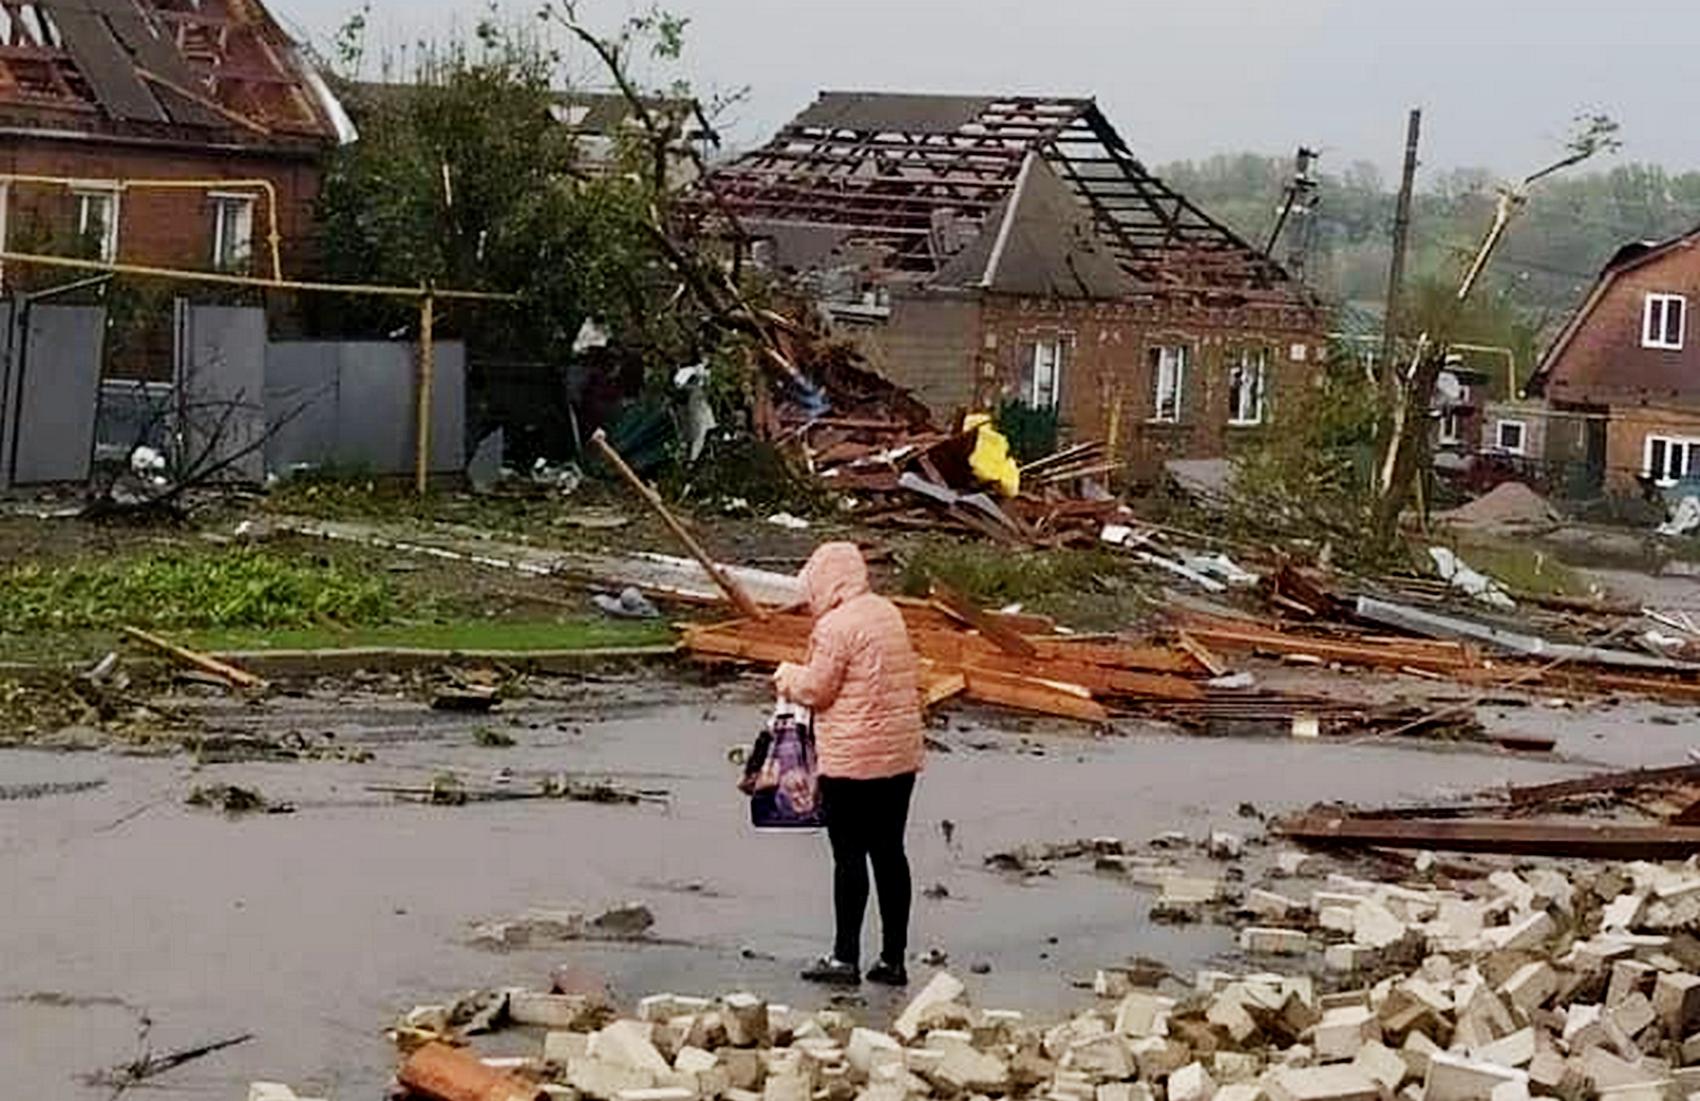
[173,618,673,652]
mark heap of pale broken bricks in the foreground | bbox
[391,863,1700,1101]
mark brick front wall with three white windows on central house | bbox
[976,297,1326,481]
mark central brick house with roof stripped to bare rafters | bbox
[709,92,1328,479]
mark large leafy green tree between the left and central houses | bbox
[320,22,717,407]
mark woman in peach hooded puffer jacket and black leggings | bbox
[774,542,923,985]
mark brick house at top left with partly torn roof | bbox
[0,0,354,288]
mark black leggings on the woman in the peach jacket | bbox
[821,773,915,967]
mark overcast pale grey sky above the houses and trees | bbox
[272,0,1700,173]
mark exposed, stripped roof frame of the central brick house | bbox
[697,92,1294,301]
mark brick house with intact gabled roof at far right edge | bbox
[1536,229,1700,493]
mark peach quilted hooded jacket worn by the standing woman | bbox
[774,542,921,780]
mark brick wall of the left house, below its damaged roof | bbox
[0,139,320,275]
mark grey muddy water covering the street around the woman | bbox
[0,669,1693,1101]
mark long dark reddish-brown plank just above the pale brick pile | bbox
[1275,814,1700,860]
